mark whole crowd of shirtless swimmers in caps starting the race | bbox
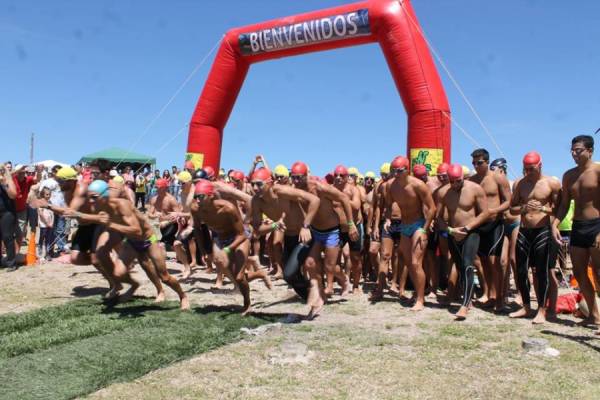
[43,135,600,324]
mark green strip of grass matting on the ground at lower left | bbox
[0,299,278,399]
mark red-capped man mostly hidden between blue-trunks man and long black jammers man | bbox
[413,164,442,297]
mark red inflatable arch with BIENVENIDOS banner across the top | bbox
[186,0,450,175]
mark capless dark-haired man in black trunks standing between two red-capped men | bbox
[469,149,510,312]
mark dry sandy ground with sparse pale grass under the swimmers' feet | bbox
[0,263,600,399]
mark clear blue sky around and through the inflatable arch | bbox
[0,0,600,175]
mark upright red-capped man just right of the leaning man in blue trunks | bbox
[325,165,363,295]
